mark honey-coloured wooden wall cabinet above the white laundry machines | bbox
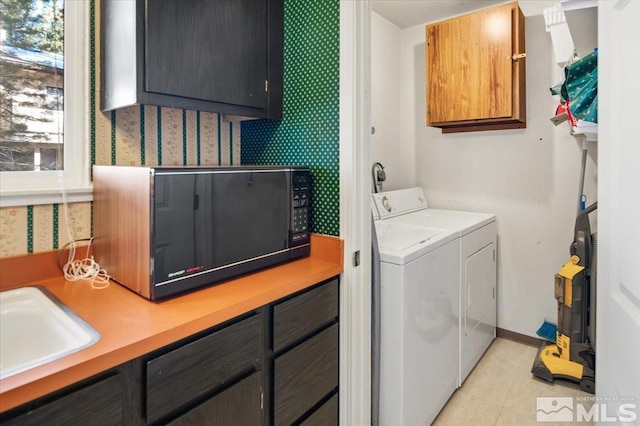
[425,3,526,133]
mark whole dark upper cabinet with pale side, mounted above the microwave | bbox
[101,0,284,119]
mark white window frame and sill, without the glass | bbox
[0,0,93,207]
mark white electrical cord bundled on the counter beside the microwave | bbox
[58,173,111,289]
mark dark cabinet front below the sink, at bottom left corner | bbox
[0,374,123,426]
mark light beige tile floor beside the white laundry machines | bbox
[434,338,593,426]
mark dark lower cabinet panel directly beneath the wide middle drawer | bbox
[169,373,262,426]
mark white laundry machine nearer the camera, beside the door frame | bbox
[374,201,460,426]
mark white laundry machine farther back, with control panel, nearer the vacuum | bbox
[373,188,497,386]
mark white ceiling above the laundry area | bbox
[371,0,560,28]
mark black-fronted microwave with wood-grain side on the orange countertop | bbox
[93,165,311,300]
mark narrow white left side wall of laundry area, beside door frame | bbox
[371,12,416,191]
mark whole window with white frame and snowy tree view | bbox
[0,0,91,207]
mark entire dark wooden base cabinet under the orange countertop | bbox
[0,278,339,426]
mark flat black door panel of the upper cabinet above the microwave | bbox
[144,0,269,108]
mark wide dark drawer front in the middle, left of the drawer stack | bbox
[146,315,262,422]
